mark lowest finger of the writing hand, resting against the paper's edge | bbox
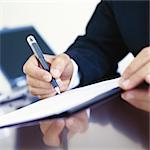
[29,86,56,96]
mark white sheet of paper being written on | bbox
[0,78,119,128]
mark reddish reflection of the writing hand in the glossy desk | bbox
[40,111,88,147]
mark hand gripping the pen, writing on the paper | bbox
[23,54,73,99]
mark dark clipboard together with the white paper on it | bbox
[0,79,122,129]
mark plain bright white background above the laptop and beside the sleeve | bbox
[0,0,100,53]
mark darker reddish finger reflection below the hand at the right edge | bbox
[122,90,150,112]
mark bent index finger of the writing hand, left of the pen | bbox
[23,56,52,82]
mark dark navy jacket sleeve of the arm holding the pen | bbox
[66,1,127,86]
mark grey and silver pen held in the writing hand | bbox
[27,35,60,94]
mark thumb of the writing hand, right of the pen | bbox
[50,53,71,79]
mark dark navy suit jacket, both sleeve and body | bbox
[66,1,149,86]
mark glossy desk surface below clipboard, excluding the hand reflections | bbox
[0,94,149,150]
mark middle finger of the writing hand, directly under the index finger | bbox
[26,75,53,89]
